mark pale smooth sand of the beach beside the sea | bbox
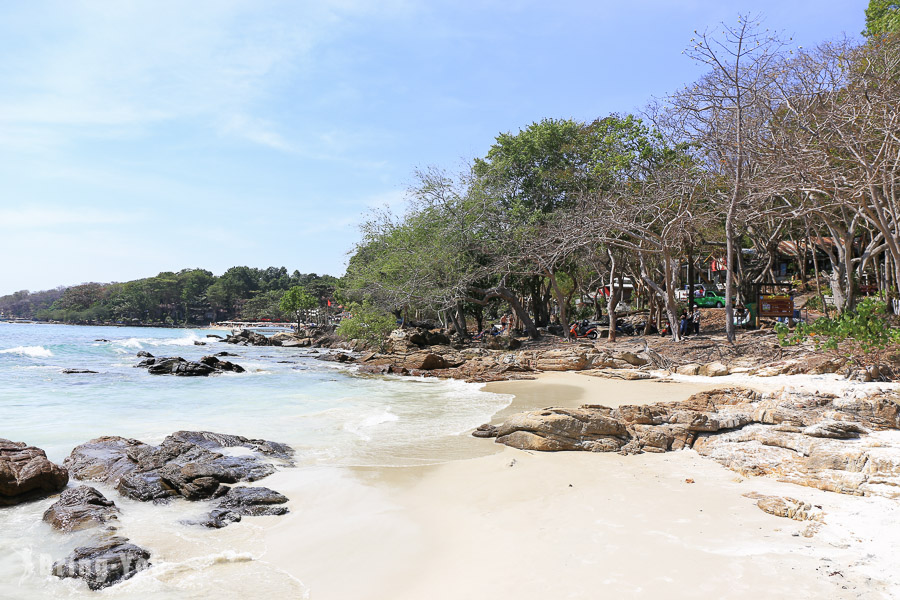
[264,373,900,600]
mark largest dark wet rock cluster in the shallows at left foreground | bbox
[64,431,293,502]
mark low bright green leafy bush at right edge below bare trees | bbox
[775,296,900,353]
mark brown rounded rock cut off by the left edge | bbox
[0,438,69,506]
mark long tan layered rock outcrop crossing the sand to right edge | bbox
[475,389,900,498]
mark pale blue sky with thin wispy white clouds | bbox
[0,0,868,295]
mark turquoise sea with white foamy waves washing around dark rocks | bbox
[0,323,512,600]
